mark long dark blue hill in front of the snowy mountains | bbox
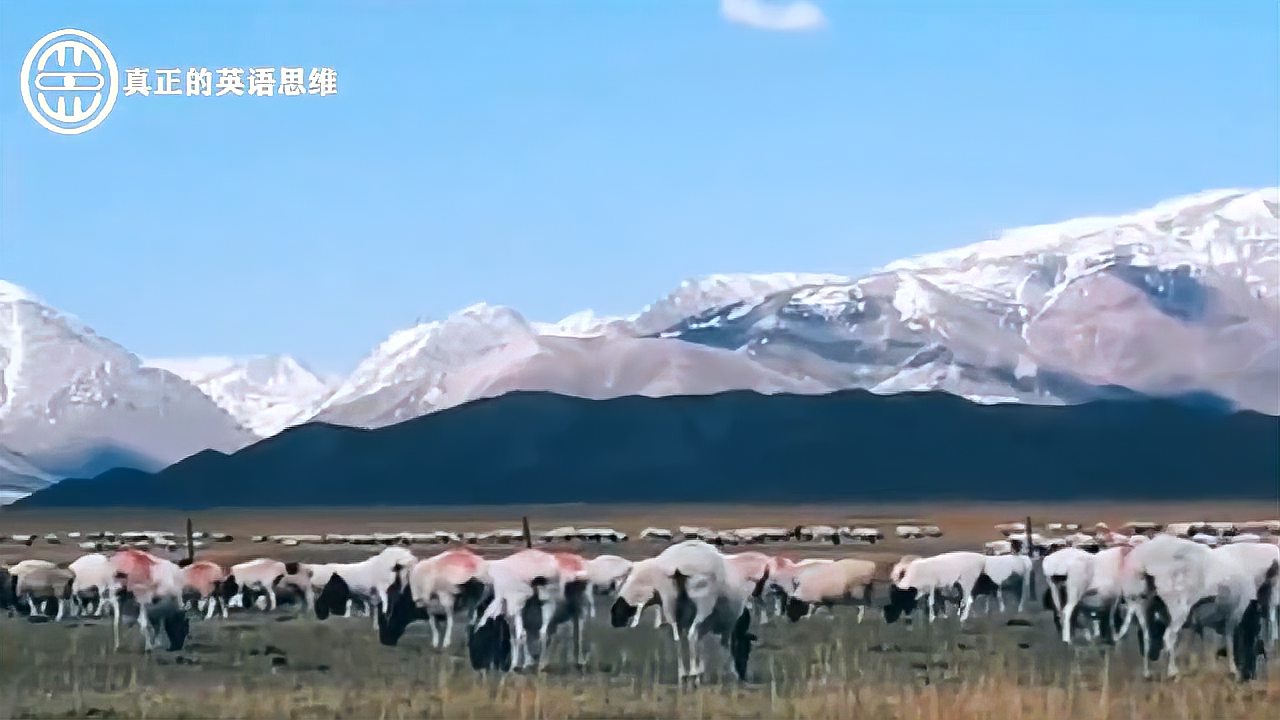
[18,391,1280,507]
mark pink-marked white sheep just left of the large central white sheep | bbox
[467,550,586,670]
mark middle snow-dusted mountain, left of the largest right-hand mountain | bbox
[314,273,844,427]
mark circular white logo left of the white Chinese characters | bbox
[19,28,120,135]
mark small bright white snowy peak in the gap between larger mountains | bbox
[146,355,333,437]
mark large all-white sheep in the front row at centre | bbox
[611,541,755,683]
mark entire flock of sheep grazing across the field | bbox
[0,521,1280,682]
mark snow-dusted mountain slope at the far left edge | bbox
[0,282,252,484]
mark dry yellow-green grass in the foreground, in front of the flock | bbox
[0,591,1280,720]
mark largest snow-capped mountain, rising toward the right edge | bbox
[660,188,1280,414]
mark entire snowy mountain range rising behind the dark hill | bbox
[0,188,1280,502]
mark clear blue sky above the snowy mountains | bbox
[0,0,1280,370]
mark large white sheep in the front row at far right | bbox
[1121,536,1262,680]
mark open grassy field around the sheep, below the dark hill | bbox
[0,503,1280,720]
